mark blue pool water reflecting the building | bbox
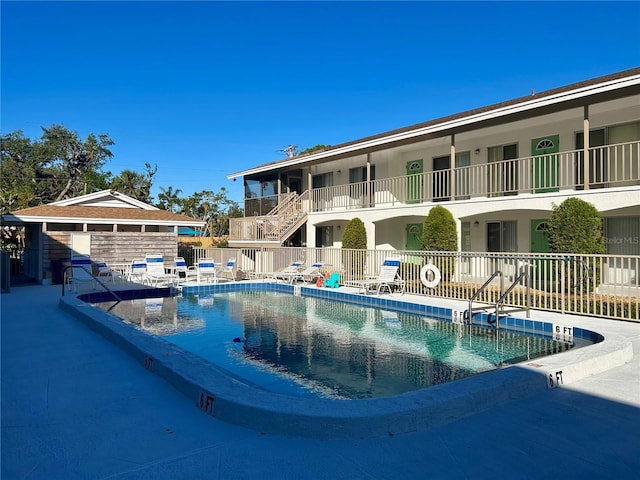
[95,291,576,399]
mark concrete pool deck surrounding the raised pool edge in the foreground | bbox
[0,286,640,480]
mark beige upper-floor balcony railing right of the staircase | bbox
[310,142,640,212]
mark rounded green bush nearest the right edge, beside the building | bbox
[547,197,606,254]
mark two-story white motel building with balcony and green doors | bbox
[228,68,640,255]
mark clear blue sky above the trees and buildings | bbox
[0,0,640,201]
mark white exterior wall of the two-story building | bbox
[231,83,640,252]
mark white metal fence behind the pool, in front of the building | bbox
[180,247,640,322]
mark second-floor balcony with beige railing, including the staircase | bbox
[230,141,640,243]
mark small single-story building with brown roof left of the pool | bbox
[2,190,204,284]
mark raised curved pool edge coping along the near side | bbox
[59,284,633,439]
